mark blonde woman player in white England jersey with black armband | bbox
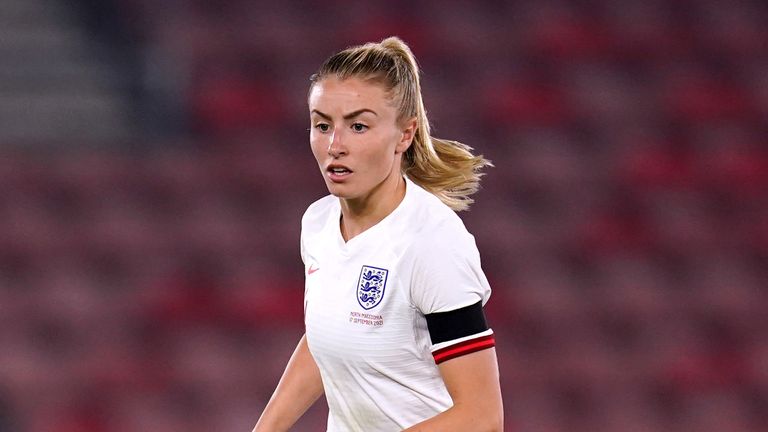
[254,37,503,432]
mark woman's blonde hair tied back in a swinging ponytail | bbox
[310,37,493,211]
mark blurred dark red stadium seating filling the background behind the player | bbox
[0,0,768,432]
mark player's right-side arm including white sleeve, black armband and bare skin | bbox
[409,218,503,431]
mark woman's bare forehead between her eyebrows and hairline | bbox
[309,76,394,111]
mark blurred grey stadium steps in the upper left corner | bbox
[0,0,129,145]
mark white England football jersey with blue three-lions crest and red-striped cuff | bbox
[301,179,493,432]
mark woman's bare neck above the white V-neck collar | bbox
[341,172,405,241]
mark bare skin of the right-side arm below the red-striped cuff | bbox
[403,348,504,432]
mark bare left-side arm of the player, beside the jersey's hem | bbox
[253,335,323,432]
